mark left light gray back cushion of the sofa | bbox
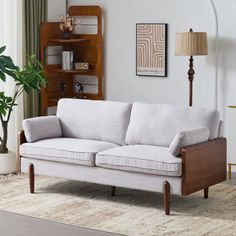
[57,99,132,145]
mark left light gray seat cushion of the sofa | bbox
[20,138,118,166]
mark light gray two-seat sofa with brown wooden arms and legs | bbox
[18,99,226,214]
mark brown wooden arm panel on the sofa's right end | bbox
[182,138,226,195]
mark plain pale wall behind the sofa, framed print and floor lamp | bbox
[48,0,236,125]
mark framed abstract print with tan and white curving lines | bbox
[136,23,167,77]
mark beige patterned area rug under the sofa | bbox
[0,175,236,236]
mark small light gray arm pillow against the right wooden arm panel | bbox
[169,128,210,156]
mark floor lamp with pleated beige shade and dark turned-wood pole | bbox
[175,29,208,106]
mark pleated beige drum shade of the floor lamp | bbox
[175,32,208,56]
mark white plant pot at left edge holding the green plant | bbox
[0,151,16,175]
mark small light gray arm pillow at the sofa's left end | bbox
[22,116,62,143]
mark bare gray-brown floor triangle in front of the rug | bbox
[0,211,121,236]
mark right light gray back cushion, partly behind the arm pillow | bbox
[126,103,219,146]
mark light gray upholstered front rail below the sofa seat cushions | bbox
[21,157,182,195]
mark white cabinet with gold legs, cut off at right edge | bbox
[227,106,236,179]
